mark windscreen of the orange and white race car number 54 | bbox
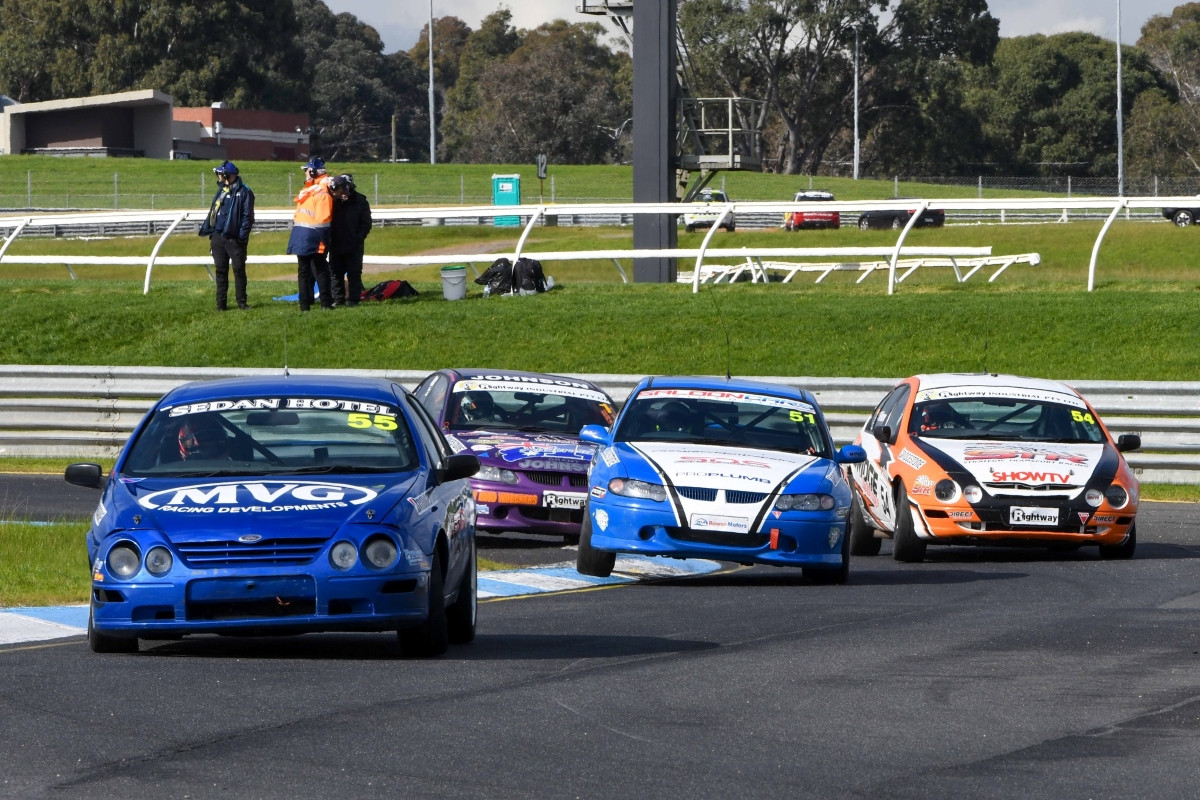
[908,387,1104,443]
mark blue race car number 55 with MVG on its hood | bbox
[66,375,479,656]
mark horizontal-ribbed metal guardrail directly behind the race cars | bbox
[0,365,1200,483]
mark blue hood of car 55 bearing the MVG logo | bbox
[111,474,416,540]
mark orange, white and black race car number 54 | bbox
[850,374,1141,561]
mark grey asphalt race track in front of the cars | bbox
[0,472,1200,799]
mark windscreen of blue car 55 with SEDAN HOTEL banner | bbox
[122,397,419,477]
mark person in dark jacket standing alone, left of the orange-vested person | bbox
[199,161,254,311]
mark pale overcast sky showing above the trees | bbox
[325,0,1180,53]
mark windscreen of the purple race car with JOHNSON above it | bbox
[445,379,616,435]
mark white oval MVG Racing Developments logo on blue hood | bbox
[138,480,378,513]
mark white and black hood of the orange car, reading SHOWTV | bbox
[919,438,1116,489]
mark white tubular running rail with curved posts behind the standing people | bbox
[0,197,1185,294]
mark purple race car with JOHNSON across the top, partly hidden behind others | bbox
[414,369,616,541]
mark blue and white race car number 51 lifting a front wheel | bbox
[576,378,866,583]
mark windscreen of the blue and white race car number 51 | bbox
[614,387,832,458]
